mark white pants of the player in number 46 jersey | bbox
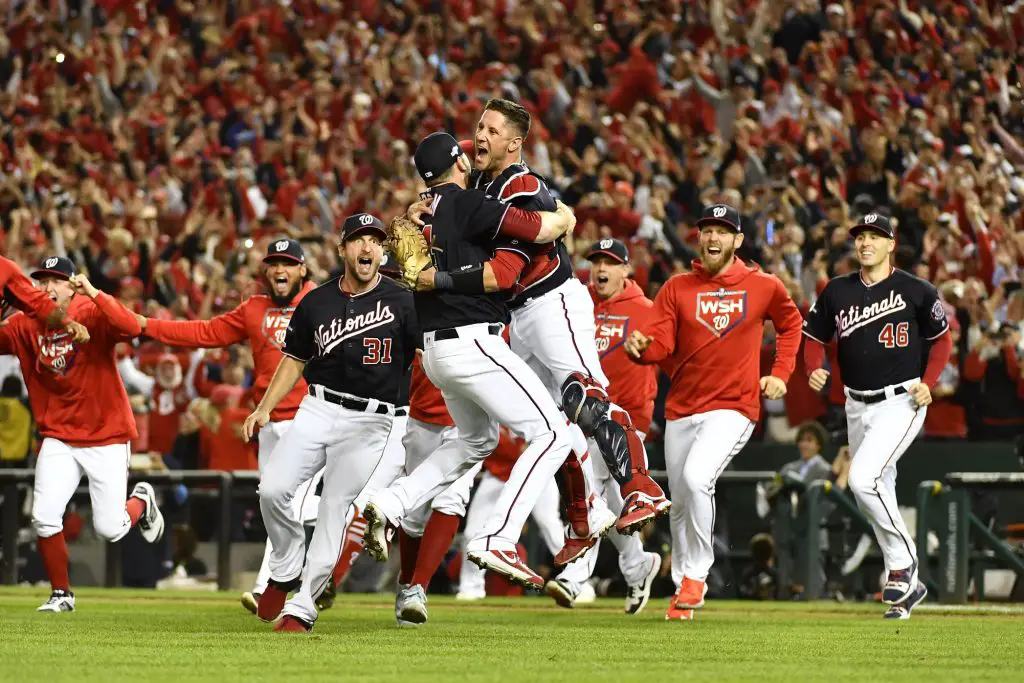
[846,379,928,571]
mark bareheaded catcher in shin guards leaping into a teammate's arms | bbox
[473,99,671,540]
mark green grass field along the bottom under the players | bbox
[0,588,1024,683]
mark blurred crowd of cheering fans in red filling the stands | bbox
[0,0,1024,532]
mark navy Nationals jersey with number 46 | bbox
[804,269,949,391]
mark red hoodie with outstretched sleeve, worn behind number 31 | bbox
[145,283,316,422]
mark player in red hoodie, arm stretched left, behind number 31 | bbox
[139,239,316,613]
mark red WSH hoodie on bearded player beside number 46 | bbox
[626,258,803,421]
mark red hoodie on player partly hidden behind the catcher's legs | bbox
[589,280,657,433]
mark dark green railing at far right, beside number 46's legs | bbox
[916,472,1024,604]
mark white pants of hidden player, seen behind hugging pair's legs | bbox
[459,471,571,598]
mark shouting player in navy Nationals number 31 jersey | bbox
[243,213,419,632]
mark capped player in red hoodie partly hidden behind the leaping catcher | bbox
[545,239,662,614]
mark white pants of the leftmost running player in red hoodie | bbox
[32,437,131,541]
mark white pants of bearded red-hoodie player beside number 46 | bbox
[665,411,754,588]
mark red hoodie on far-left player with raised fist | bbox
[0,292,141,447]
